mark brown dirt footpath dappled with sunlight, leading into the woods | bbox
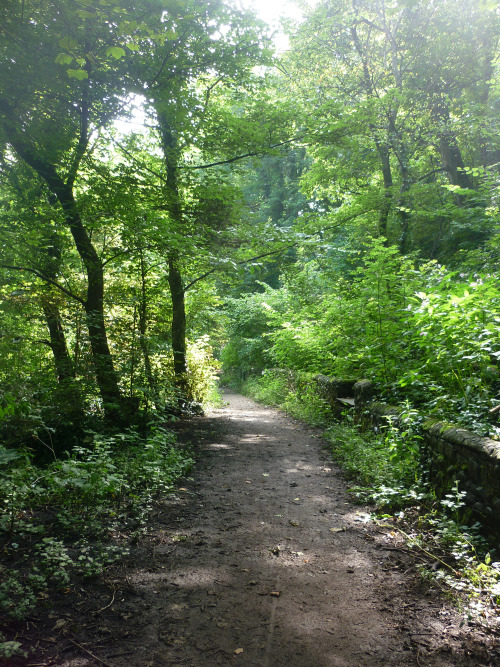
[16,394,500,667]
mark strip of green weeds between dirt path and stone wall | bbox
[241,371,500,631]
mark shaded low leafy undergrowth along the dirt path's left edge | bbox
[0,424,193,657]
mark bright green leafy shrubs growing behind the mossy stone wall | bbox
[223,239,500,437]
